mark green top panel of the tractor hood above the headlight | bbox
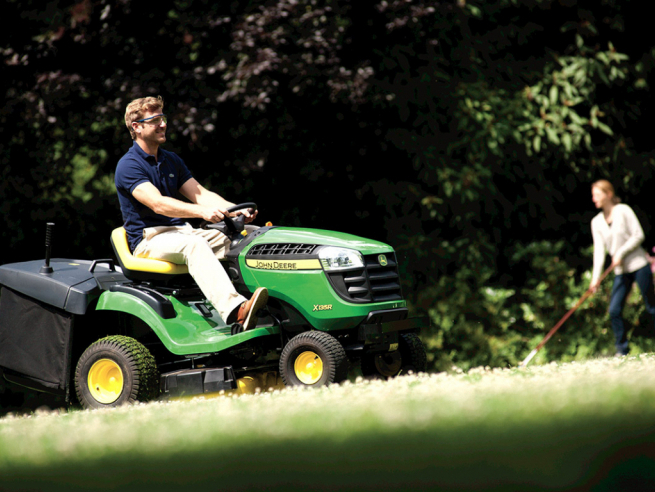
[251,227,393,255]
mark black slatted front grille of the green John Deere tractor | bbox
[327,253,403,303]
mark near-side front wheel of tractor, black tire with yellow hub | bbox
[280,331,348,387]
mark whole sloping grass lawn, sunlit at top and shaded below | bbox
[0,355,655,491]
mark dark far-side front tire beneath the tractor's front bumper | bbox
[362,333,427,379]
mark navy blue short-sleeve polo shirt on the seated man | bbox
[114,141,192,252]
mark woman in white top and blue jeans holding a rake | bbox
[590,179,655,355]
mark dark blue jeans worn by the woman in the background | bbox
[609,265,655,355]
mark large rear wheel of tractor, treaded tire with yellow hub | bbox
[75,335,159,408]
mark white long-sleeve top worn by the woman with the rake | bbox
[591,203,648,283]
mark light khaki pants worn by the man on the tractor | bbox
[134,224,250,321]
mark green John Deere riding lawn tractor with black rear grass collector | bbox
[0,203,429,408]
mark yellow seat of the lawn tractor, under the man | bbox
[111,227,189,280]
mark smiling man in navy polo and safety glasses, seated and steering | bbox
[115,97,268,329]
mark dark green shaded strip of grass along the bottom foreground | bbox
[0,415,655,492]
